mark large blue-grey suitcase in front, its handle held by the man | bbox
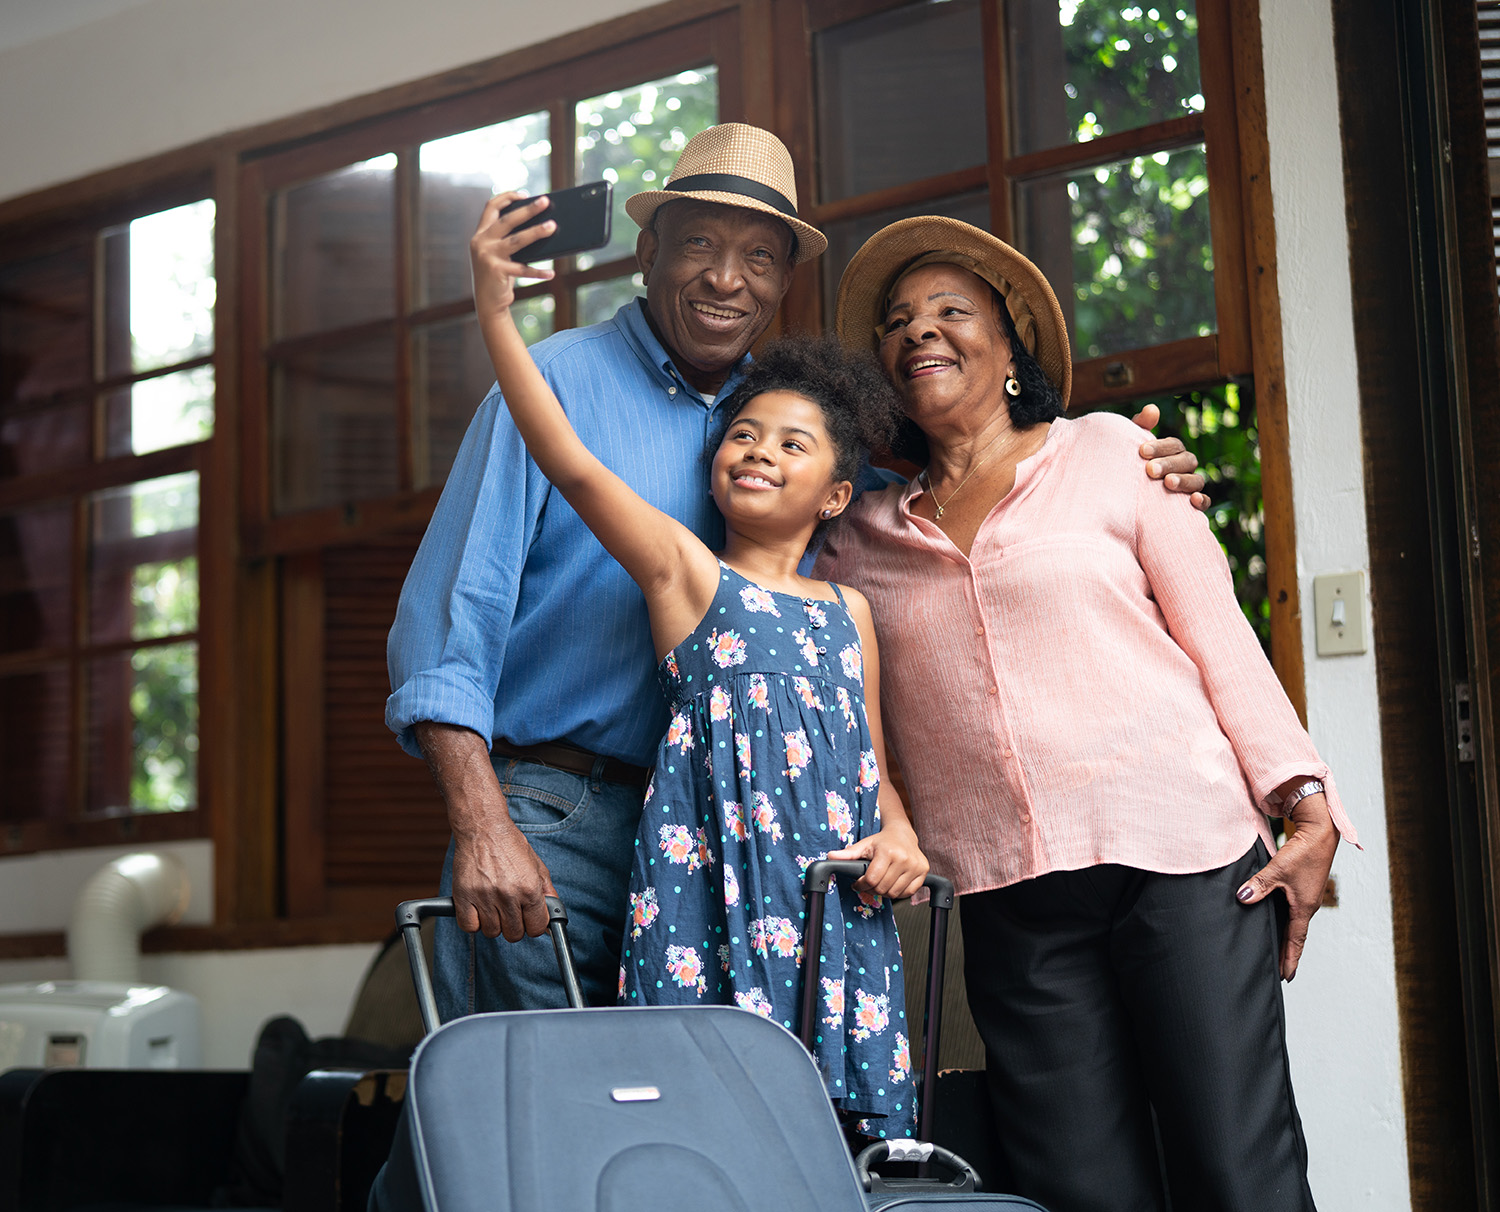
[398,900,866,1212]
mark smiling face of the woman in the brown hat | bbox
[879,263,1014,428]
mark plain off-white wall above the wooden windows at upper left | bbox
[0,0,657,200]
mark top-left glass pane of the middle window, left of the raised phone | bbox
[270,155,396,338]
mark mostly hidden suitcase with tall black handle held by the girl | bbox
[801,858,1044,1212]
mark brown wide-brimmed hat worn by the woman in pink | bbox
[836,215,1073,408]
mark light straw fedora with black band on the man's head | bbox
[626,122,828,261]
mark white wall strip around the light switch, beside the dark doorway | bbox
[1262,0,1410,1212]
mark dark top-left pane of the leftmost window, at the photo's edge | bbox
[0,242,93,408]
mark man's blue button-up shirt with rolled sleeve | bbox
[386,299,749,765]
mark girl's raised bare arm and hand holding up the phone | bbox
[470,194,719,653]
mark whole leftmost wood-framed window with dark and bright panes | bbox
[0,189,216,846]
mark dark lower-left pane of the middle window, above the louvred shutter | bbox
[272,335,398,513]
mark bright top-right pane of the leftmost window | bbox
[105,198,216,373]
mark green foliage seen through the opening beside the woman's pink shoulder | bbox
[1113,383,1271,657]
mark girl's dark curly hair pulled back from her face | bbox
[710,336,902,483]
